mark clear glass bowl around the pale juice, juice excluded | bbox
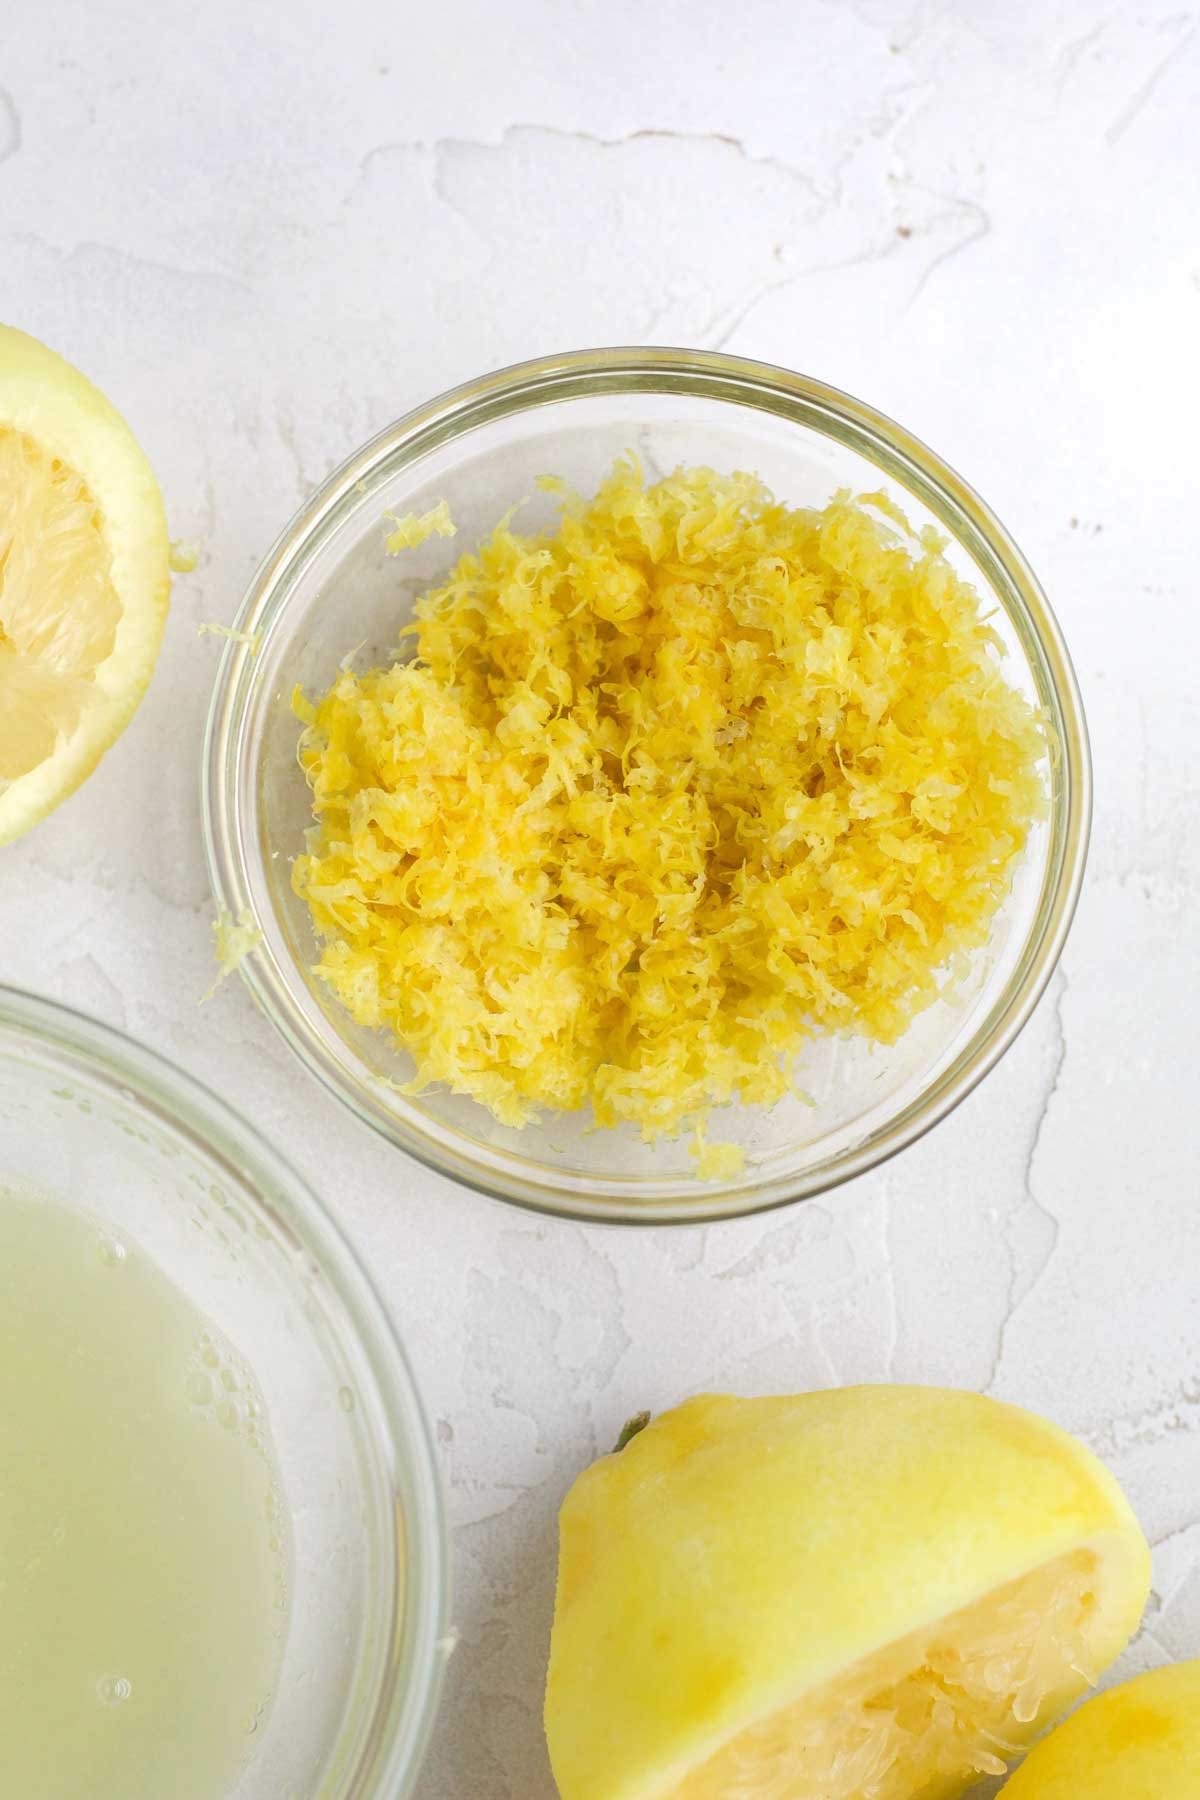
[0,988,448,1800]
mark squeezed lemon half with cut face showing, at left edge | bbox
[0,326,169,844]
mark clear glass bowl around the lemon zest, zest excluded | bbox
[203,349,1090,1224]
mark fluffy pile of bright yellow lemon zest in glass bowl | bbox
[293,459,1047,1144]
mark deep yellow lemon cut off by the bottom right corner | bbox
[1002,1663,1200,1800]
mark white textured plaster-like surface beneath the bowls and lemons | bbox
[0,0,1200,1800]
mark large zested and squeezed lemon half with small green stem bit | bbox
[545,1386,1150,1800]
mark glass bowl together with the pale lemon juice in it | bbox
[0,988,448,1800]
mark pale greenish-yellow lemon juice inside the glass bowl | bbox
[0,1190,288,1800]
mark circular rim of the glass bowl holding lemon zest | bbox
[200,347,1092,1226]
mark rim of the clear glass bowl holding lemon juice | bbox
[0,983,450,1800]
